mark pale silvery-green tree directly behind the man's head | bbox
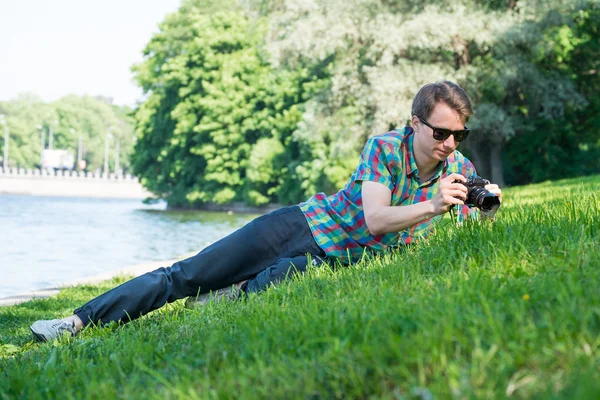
[245,0,591,185]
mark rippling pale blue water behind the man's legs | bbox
[0,196,255,298]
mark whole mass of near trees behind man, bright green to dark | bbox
[129,0,600,206]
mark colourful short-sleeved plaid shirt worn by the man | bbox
[300,127,477,262]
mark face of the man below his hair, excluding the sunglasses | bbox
[412,103,465,164]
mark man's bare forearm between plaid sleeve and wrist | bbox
[366,200,436,235]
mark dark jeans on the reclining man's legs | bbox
[75,206,325,325]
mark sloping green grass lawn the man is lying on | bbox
[0,176,600,399]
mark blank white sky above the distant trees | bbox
[0,0,180,106]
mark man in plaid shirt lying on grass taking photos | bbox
[31,81,501,341]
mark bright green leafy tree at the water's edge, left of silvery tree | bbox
[134,1,328,206]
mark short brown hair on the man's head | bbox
[412,81,473,123]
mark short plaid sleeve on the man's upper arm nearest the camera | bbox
[351,137,395,191]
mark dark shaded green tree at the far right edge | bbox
[505,2,600,183]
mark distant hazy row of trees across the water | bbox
[0,94,135,171]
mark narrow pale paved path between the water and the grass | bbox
[0,253,196,307]
